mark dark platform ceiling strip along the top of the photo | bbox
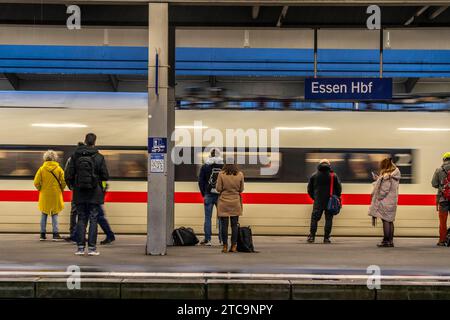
[0,1,450,28]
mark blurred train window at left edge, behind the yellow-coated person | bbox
[0,150,64,178]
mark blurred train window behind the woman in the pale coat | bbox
[305,150,413,183]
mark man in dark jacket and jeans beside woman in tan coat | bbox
[198,149,223,246]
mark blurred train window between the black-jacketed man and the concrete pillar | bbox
[100,150,147,179]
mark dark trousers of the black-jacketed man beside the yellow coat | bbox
[77,203,100,250]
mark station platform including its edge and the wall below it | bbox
[0,234,450,300]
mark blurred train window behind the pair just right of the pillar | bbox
[196,151,282,179]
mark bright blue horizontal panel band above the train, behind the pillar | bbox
[0,45,450,78]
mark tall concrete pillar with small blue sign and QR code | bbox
[146,3,175,255]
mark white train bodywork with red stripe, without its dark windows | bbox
[0,94,450,236]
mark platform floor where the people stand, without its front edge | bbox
[0,234,450,277]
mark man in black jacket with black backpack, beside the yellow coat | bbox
[65,133,109,256]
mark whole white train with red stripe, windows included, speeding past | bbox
[0,91,450,236]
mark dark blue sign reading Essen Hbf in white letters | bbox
[305,78,392,100]
